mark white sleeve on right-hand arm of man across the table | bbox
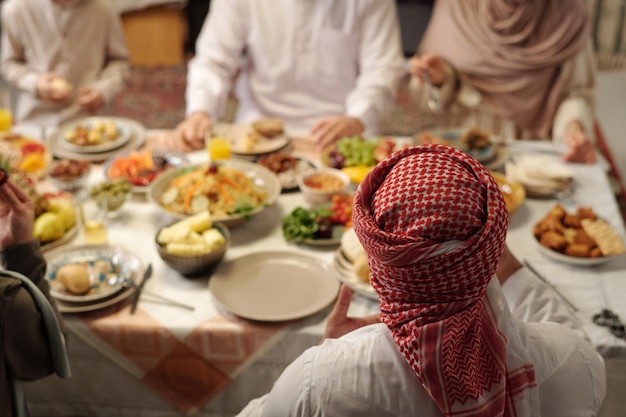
[346,0,406,134]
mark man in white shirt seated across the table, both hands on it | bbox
[174,0,406,150]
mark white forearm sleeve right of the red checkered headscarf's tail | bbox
[502,268,589,340]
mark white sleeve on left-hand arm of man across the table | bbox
[185,0,248,119]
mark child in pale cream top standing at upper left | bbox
[0,0,130,127]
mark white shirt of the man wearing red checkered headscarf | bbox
[239,269,606,417]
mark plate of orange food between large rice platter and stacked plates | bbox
[104,149,189,192]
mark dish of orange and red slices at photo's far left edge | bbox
[0,132,52,177]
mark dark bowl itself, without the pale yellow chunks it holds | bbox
[154,223,230,277]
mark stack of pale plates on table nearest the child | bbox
[49,116,146,162]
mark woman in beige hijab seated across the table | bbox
[410,0,596,163]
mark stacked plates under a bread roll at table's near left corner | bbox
[45,245,144,313]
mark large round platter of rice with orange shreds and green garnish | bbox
[148,160,280,226]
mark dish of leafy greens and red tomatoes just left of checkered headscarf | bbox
[282,194,352,245]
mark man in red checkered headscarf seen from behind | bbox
[239,144,606,417]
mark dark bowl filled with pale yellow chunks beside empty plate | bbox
[155,211,230,277]
